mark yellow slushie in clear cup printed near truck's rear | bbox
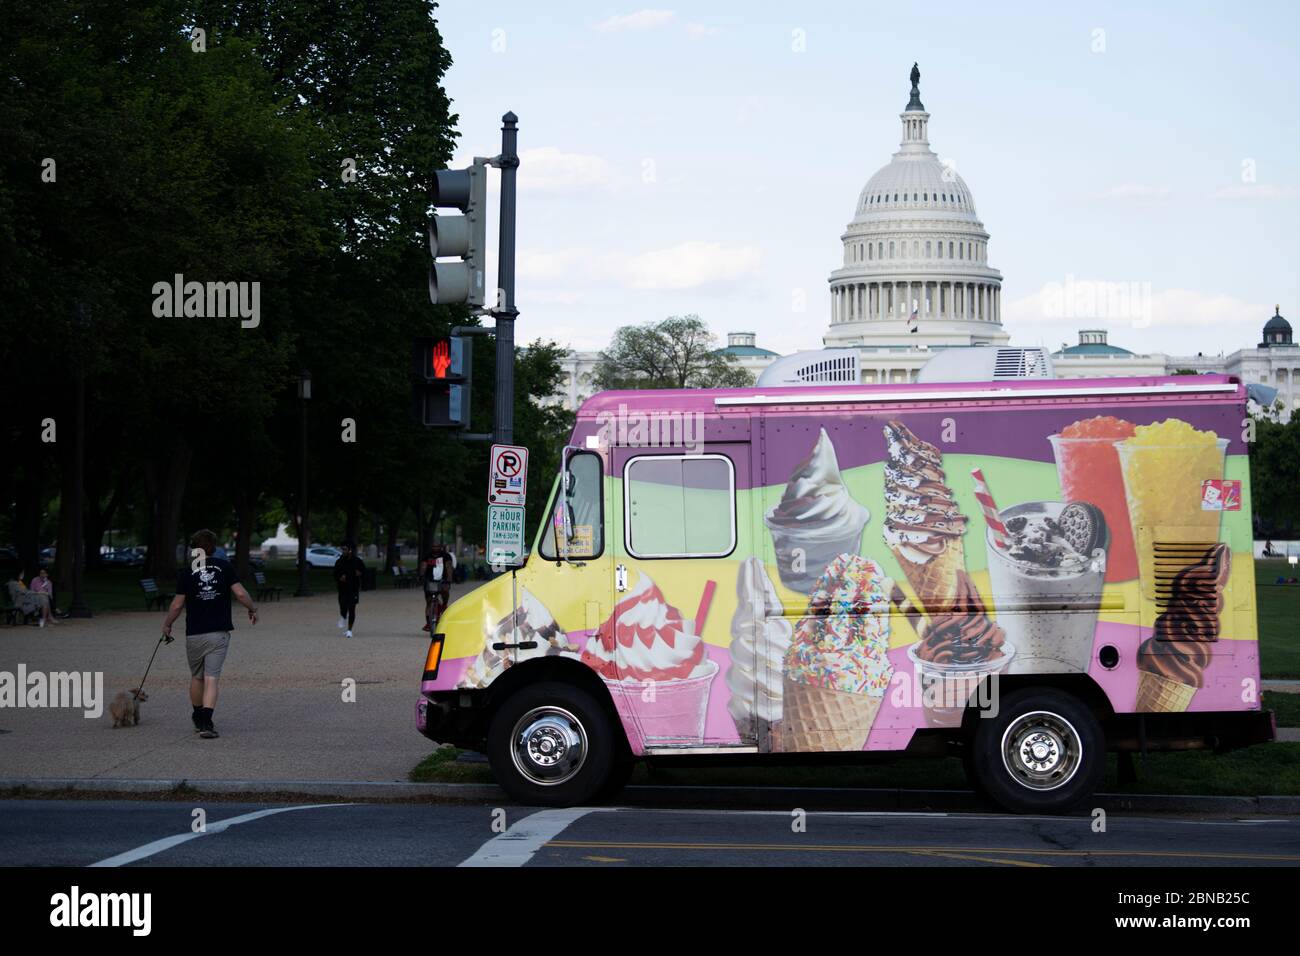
[1115,419,1227,587]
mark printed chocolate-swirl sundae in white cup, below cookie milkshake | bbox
[894,571,1015,727]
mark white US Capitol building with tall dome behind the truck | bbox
[555,64,1300,420]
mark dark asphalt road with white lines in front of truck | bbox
[0,800,1300,868]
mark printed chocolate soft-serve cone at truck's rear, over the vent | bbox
[1136,544,1232,713]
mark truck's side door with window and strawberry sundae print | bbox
[610,441,757,750]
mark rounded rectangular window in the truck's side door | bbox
[623,455,736,558]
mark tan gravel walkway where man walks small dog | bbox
[0,583,476,780]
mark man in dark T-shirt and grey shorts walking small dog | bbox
[163,528,257,740]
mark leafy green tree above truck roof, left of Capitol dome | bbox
[592,315,754,389]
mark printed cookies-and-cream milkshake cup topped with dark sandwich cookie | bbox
[985,501,1108,674]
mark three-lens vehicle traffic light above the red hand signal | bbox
[429,164,488,306]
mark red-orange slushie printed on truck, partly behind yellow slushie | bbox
[1048,415,1138,581]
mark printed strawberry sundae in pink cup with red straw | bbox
[582,571,718,752]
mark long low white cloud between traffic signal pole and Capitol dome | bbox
[517,242,762,294]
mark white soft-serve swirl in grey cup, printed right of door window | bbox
[763,428,871,594]
